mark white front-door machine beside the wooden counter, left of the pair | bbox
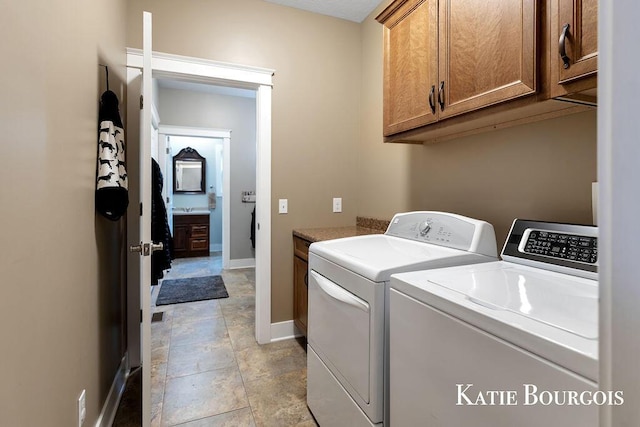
[307,212,497,427]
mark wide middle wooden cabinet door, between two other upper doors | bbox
[437,0,539,118]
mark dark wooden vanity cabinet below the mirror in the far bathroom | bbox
[173,215,209,258]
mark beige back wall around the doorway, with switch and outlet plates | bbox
[128,0,361,322]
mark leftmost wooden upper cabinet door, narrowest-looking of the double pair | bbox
[379,0,438,136]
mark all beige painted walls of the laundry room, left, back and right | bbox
[0,0,596,426]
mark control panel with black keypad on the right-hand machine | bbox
[501,219,598,279]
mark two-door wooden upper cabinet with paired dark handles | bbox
[376,0,538,136]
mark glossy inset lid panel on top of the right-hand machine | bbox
[428,267,598,340]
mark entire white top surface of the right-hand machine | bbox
[391,261,598,381]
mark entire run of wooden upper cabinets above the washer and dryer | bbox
[376,0,598,144]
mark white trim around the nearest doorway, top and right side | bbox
[127,48,274,344]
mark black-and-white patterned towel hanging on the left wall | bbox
[96,90,129,221]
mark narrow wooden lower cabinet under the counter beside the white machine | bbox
[293,236,311,337]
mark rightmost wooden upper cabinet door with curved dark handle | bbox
[551,0,598,96]
